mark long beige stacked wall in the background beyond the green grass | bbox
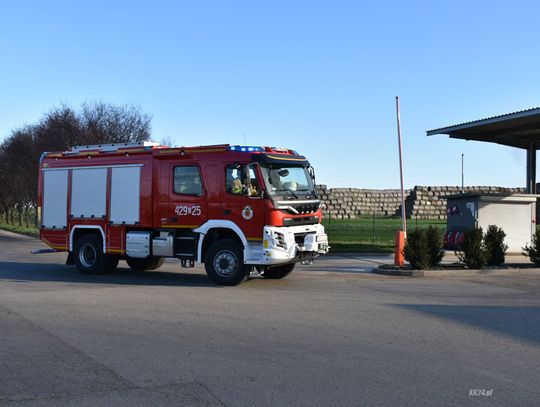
[317,185,525,219]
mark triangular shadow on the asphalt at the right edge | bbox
[393,304,540,344]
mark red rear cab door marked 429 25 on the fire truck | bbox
[161,161,207,229]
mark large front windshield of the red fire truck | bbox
[261,164,316,199]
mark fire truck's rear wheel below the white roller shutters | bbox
[73,235,119,274]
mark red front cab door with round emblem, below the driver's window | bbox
[222,163,266,243]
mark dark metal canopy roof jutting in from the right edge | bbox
[427,107,540,150]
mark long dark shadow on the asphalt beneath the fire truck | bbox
[0,262,220,288]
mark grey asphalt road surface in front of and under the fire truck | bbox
[0,232,540,407]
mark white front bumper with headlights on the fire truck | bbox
[245,224,330,265]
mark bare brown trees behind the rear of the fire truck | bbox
[0,102,152,227]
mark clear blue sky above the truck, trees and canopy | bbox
[0,0,540,188]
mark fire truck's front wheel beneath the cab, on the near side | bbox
[204,239,251,285]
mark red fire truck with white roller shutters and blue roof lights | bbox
[38,143,329,285]
